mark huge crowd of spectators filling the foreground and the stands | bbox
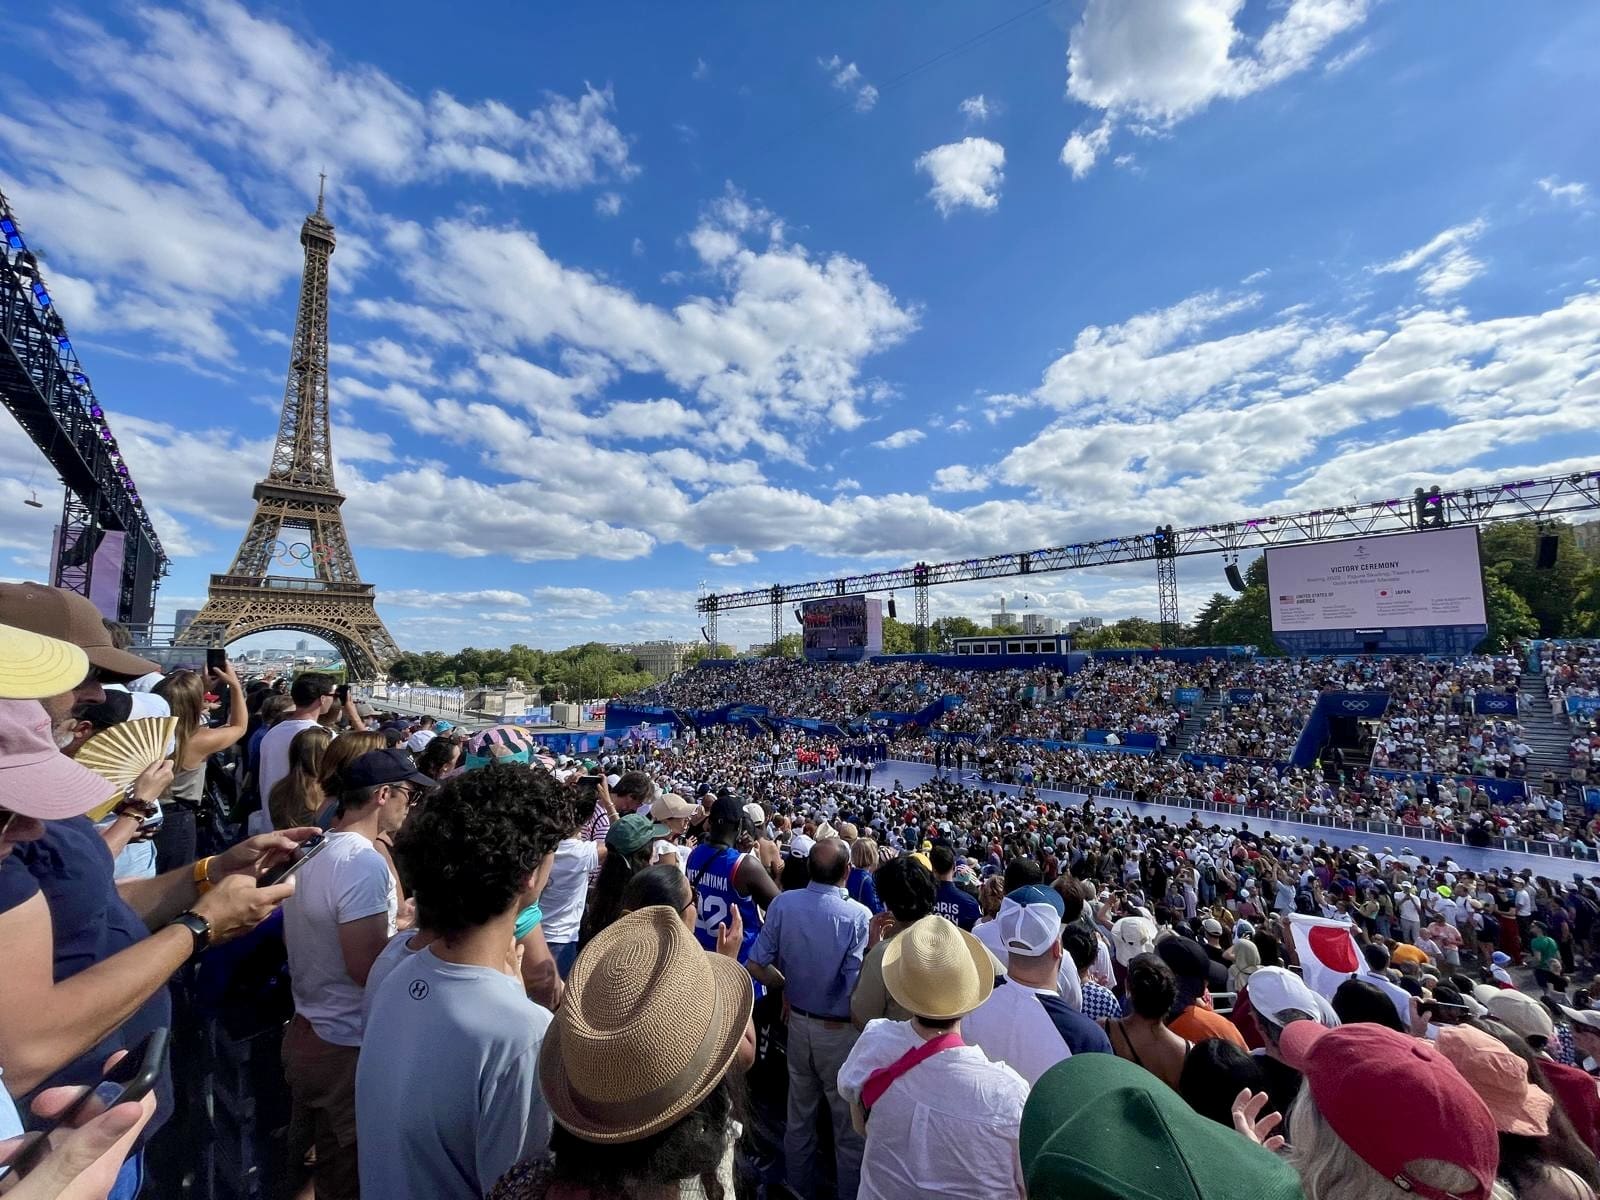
[9,584,1600,1200]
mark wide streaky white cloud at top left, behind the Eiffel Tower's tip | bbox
[0,0,637,371]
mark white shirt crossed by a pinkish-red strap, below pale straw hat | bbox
[838,1021,1024,1200]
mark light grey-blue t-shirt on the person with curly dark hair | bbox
[355,949,550,1200]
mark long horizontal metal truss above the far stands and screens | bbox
[696,470,1600,651]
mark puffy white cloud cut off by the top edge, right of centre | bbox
[1061,0,1368,178]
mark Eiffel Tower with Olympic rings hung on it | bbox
[176,187,400,680]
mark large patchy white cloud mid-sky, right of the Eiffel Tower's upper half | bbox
[402,192,918,458]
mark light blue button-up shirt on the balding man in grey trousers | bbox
[750,883,872,1021]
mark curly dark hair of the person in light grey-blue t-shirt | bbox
[394,765,578,936]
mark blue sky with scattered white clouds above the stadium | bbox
[0,0,1600,648]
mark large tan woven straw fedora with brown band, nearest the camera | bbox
[539,904,755,1142]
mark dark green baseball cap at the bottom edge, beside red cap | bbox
[1018,1054,1304,1200]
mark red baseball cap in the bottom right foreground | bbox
[1278,1021,1499,1200]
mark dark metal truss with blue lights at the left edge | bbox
[0,185,168,622]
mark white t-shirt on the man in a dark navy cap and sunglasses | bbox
[283,832,397,1046]
